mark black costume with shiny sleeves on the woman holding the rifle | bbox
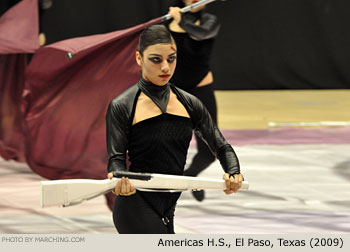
[106,79,240,234]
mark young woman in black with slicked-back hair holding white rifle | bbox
[106,25,242,234]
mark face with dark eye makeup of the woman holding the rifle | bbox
[136,43,176,86]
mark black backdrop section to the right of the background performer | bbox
[209,0,350,89]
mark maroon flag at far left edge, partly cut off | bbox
[0,0,39,162]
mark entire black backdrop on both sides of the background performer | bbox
[0,0,350,89]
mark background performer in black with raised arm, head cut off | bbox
[168,0,220,201]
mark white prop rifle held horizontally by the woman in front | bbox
[40,171,249,207]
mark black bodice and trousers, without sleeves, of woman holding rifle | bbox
[114,113,192,233]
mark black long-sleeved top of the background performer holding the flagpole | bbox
[170,12,220,92]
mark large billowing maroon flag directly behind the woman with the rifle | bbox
[24,18,160,207]
